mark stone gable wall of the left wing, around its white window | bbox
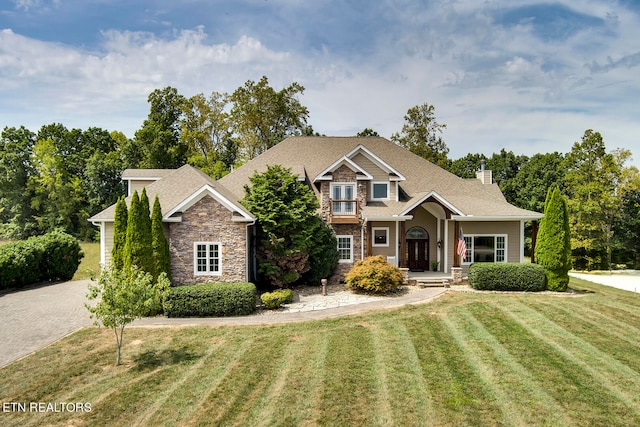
[169,196,247,285]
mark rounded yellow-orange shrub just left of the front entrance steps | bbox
[344,255,404,293]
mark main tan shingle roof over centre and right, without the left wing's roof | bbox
[220,137,542,219]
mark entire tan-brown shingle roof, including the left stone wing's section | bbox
[90,137,542,226]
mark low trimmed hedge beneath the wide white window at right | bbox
[469,262,547,292]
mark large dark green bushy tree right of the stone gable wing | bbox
[242,165,338,288]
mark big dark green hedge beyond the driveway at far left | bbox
[0,231,84,289]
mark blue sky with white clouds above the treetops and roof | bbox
[0,0,640,165]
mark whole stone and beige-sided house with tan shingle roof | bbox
[90,137,542,284]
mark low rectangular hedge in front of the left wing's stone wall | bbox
[163,283,256,317]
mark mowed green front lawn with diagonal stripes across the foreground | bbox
[0,279,640,426]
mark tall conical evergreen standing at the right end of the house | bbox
[536,187,571,291]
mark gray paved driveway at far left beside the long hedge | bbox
[0,280,93,367]
